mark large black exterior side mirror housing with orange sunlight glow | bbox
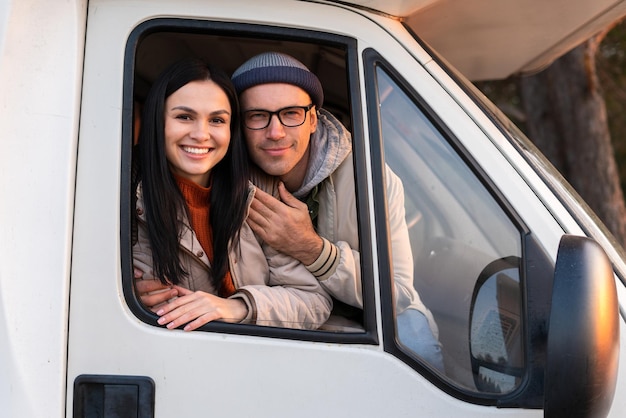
[544,235,619,417]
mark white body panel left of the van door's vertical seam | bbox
[0,1,87,417]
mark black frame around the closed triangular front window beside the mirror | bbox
[362,48,554,408]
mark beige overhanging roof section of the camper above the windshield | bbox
[341,0,626,81]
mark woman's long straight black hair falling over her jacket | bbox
[138,59,249,289]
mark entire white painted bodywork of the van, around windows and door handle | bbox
[0,0,626,417]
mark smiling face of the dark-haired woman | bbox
[164,80,232,187]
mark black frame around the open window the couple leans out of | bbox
[120,18,379,345]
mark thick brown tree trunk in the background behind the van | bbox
[519,39,626,245]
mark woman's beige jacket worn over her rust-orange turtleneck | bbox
[133,184,332,329]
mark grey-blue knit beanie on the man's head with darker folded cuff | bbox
[231,52,324,109]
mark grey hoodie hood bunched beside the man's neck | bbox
[293,109,352,198]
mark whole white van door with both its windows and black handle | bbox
[67,0,616,417]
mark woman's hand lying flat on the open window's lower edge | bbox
[156,286,248,331]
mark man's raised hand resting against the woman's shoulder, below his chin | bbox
[248,182,324,265]
